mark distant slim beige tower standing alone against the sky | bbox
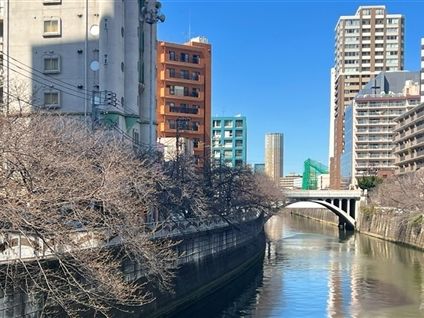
[265,133,284,185]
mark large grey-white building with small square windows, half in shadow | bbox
[3,0,164,143]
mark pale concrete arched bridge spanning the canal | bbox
[283,190,363,230]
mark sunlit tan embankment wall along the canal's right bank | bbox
[290,209,424,250]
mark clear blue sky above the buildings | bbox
[158,0,424,174]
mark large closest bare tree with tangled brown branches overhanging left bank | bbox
[0,115,177,316]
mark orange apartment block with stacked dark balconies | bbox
[157,37,212,165]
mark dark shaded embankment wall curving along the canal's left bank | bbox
[133,218,265,317]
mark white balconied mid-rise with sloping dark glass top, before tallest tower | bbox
[341,72,420,189]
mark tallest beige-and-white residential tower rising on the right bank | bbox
[329,6,404,189]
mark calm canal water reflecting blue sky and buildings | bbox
[171,213,424,318]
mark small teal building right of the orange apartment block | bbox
[211,116,247,167]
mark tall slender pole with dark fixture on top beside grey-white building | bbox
[141,0,165,148]
